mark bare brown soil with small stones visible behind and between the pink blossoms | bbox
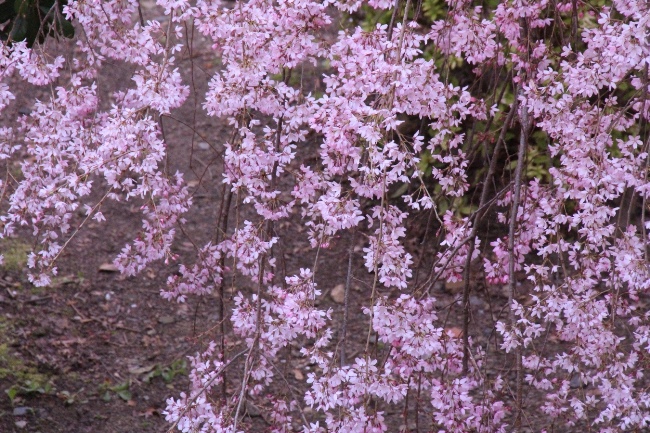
[0,6,536,433]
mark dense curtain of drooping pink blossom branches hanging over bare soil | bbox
[0,0,650,433]
